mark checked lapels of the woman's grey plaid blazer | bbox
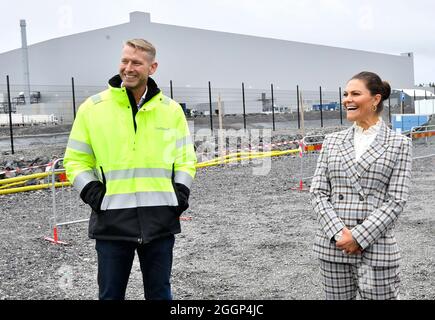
[339,121,390,196]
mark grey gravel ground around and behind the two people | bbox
[0,138,435,300]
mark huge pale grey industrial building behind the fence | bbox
[0,12,414,119]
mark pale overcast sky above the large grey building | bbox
[0,0,435,84]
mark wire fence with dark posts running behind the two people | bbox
[0,78,435,130]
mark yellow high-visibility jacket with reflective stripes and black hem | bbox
[64,76,196,243]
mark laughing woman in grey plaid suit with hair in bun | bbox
[310,72,412,300]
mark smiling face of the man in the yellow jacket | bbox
[119,45,157,91]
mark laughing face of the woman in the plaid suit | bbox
[343,79,381,127]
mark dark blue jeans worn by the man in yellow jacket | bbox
[95,235,175,300]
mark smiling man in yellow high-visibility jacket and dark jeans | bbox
[64,39,196,299]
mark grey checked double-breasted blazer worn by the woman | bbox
[310,122,412,267]
